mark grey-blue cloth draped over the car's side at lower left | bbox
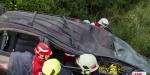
[8,51,32,75]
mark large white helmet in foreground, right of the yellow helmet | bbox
[76,54,99,72]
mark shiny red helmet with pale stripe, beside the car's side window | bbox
[34,43,52,55]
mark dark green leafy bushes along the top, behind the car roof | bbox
[1,0,140,21]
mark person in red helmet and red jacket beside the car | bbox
[32,42,52,75]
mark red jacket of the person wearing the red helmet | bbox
[32,55,45,75]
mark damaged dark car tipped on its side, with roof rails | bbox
[0,11,150,75]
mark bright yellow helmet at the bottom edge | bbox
[42,58,61,75]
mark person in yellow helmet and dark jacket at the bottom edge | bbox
[42,58,73,75]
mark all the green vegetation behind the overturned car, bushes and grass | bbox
[0,0,150,58]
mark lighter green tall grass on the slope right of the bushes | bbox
[111,2,150,58]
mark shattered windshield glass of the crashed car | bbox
[114,37,150,72]
